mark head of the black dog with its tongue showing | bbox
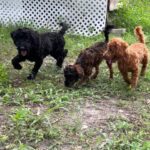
[11,28,38,57]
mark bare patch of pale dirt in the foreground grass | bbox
[56,99,141,130]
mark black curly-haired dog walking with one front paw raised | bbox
[11,23,68,80]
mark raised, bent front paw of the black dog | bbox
[11,55,25,70]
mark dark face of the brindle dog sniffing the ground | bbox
[64,65,79,87]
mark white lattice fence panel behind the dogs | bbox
[0,0,107,35]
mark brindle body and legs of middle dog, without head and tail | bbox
[75,42,112,80]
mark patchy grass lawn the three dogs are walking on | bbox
[0,24,150,150]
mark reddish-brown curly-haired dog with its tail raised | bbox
[106,26,148,88]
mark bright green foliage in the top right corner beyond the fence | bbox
[110,0,150,34]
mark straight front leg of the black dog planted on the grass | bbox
[27,59,43,80]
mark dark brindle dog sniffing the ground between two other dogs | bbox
[64,25,113,87]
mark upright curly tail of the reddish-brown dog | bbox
[134,26,145,43]
